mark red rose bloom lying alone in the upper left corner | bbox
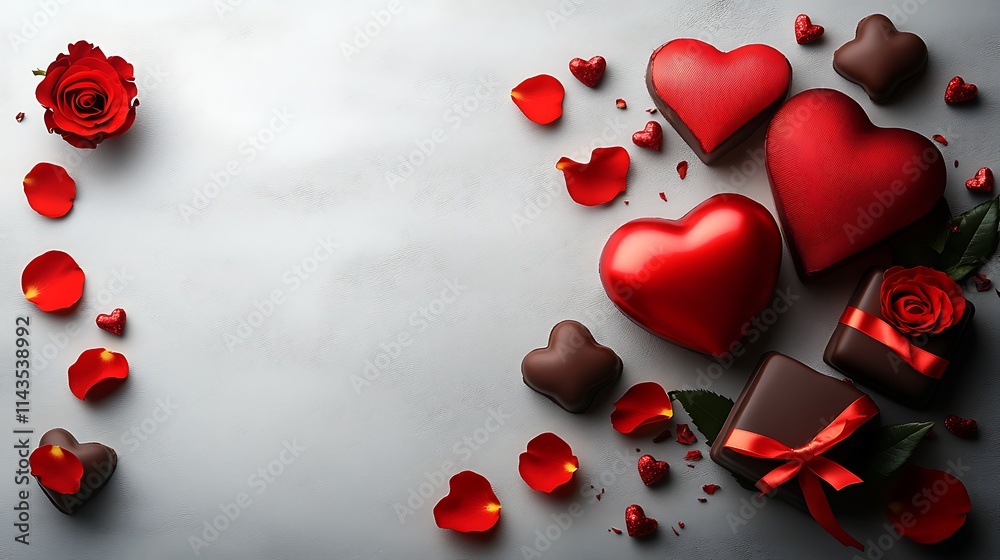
[35,41,139,148]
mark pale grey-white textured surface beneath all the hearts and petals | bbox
[0,0,1000,560]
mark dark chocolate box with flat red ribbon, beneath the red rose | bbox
[823,268,976,407]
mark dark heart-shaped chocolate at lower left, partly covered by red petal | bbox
[35,428,118,515]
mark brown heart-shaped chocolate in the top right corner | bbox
[833,14,927,103]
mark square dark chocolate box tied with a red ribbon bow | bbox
[711,352,879,548]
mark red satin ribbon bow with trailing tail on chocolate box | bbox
[725,395,878,550]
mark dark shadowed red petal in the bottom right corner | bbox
[887,465,972,544]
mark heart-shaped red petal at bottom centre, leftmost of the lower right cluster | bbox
[434,471,500,533]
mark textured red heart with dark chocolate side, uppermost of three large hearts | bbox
[646,39,792,163]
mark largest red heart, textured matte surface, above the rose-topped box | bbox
[765,89,946,280]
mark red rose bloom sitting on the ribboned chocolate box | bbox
[880,266,965,335]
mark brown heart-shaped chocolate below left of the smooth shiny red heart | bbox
[521,321,622,414]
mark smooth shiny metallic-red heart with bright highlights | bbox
[600,194,781,355]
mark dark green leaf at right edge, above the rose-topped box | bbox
[941,197,1000,281]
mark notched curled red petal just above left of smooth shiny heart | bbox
[556,146,631,206]
